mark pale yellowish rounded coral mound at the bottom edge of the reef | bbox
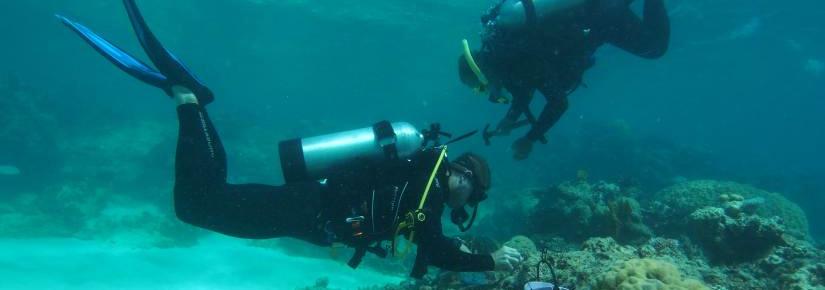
[594,259,710,290]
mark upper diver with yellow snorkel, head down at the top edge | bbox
[458,0,670,160]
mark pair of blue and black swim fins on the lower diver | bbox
[56,0,214,105]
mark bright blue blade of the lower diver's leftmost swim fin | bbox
[55,15,168,87]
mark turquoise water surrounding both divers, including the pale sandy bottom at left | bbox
[0,0,825,289]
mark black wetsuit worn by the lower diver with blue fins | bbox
[174,104,494,277]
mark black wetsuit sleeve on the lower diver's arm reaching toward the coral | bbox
[412,212,495,278]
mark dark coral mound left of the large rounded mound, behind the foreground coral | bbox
[530,181,652,244]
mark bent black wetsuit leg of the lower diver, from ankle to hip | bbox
[174,104,322,240]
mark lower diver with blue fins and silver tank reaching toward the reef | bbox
[58,0,522,278]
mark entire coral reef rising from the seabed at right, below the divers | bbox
[371,178,825,290]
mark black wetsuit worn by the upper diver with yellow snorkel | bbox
[480,0,670,141]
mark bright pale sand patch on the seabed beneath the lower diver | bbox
[0,235,402,289]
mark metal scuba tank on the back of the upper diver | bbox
[496,0,587,29]
